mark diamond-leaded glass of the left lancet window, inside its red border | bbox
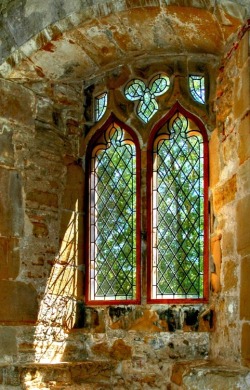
[90,124,136,300]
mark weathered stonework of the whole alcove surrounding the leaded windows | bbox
[0,0,250,389]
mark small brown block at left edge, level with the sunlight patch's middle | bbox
[0,237,20,279]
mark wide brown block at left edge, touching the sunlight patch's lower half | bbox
[0,280,38,323]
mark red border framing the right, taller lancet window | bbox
[147,101,209,304]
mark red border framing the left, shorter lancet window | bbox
[84,113,141,306]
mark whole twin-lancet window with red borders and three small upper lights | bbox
[86,73,208,305]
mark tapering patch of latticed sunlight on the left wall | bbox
[34,201,79,363]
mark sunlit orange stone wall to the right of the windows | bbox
[210,27,250,364]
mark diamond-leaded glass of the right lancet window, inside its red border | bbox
[152,114,204,299]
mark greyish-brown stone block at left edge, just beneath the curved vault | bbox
[0,79,35,126]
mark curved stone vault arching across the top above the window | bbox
[0,0,250,80]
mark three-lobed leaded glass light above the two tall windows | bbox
[125,74,170,123]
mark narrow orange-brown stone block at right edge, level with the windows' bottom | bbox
[240,255,250,321]
